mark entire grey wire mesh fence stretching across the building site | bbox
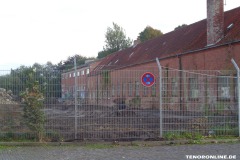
[0,65,238,141]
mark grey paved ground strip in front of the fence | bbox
[0,143,240,160]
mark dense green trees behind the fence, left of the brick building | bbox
[0,62,61,100]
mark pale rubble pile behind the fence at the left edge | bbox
[0,88,17,104]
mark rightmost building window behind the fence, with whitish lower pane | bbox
[217,76,230,100]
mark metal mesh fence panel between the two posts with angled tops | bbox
[162,69,238,135]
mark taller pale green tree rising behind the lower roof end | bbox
[97,22,132,58]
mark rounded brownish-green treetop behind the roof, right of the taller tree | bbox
[138,26,163,42]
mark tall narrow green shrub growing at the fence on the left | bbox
[21,68,45,142]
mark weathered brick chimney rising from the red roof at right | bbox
[207,0,224,46]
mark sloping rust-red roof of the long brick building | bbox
[95,7,240,70]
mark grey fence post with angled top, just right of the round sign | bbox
[156,58,163,138]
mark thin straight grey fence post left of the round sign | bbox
[74,57,77,139]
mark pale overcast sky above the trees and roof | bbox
[0,0,240,70]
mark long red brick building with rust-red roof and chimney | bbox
[62,0,240,109]
